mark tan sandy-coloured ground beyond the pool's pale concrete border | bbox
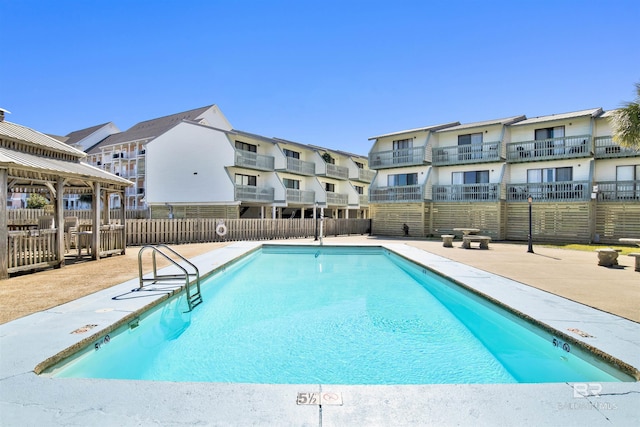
[0,236,640,324]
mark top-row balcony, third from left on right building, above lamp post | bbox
[507,135,592,163]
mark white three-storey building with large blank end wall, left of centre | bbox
[75,105,374,218]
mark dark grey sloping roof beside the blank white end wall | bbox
[88,105,214,154]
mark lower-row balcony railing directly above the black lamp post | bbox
[507,181,591,202]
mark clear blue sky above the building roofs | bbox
[0,0,640,154]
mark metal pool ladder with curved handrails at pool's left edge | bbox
[138,245,202,311]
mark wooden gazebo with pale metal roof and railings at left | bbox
[0,109,132,279]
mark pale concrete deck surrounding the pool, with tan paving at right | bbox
[0,237,640,426]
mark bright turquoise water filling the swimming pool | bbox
[54,246,631,384]
